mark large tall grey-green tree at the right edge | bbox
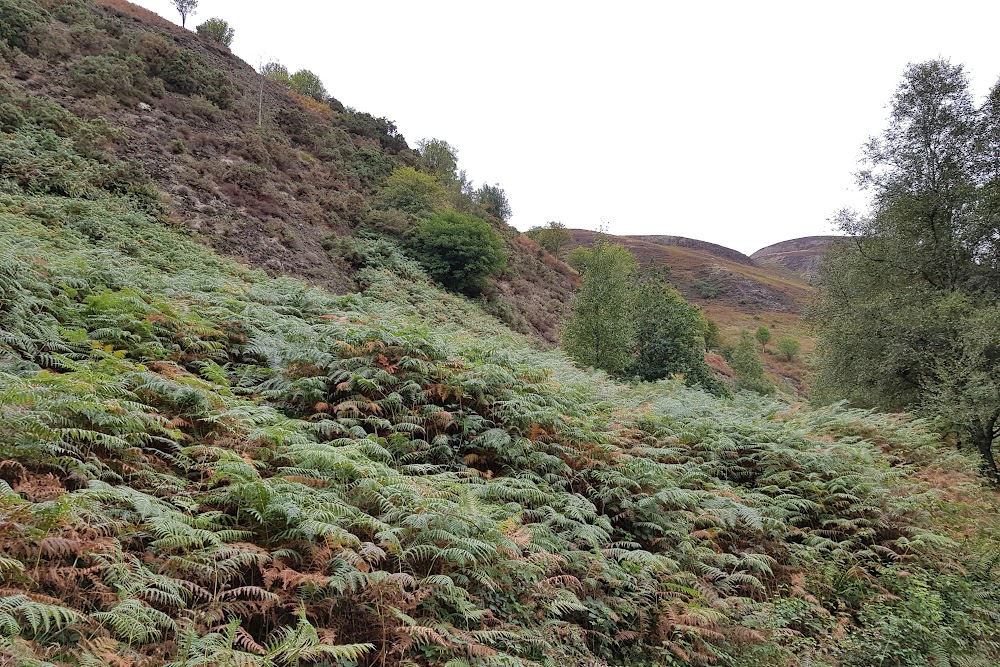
[811,60,1000,475]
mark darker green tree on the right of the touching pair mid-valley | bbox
[630,275,722,393]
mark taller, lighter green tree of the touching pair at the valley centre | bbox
[562,241,639,373]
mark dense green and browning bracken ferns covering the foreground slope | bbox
[0,69,1000,667]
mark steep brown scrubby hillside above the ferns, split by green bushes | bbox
[0,0,575,342]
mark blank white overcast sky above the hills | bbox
[137,0,1000,253]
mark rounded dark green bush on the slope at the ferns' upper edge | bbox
[413,211,509,295]
